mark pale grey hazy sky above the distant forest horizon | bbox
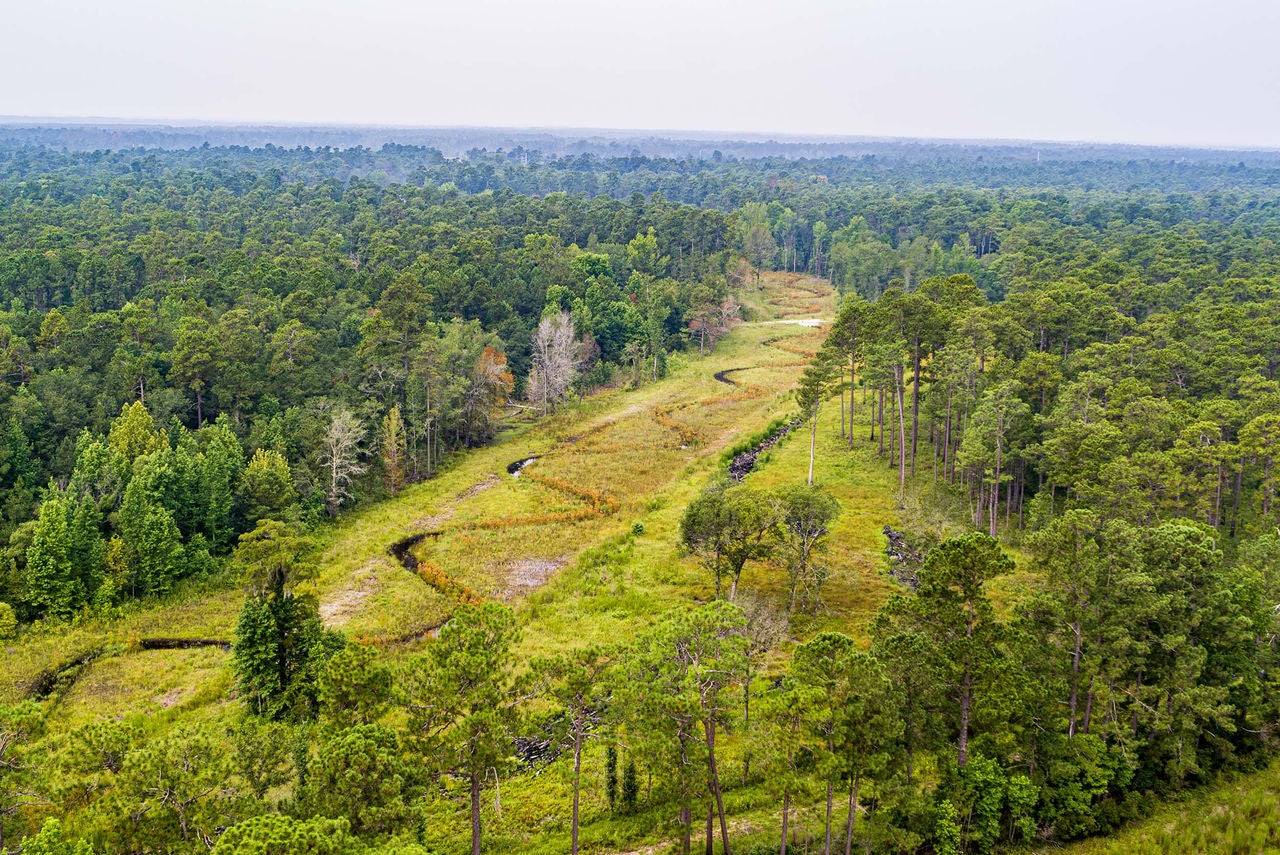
[10,0,1280,147]
